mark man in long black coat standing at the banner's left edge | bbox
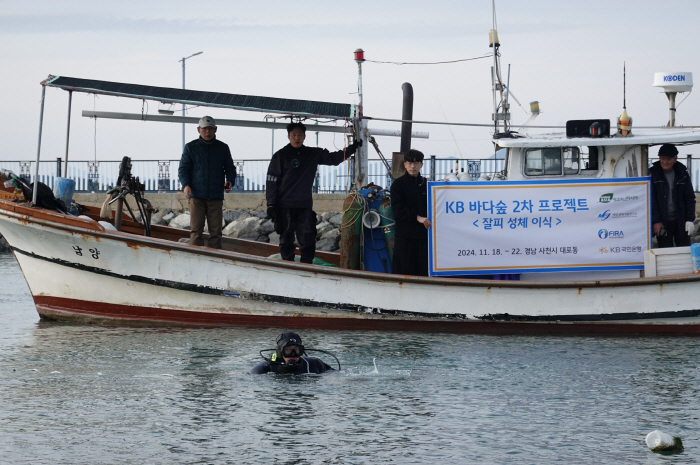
[391,149,432,276]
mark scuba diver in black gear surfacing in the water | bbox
[250,331,340,375]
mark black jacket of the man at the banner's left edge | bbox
[391,173,428,239]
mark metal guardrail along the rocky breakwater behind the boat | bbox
[0,156,700,193]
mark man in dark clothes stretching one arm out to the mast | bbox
[266,123,362,263]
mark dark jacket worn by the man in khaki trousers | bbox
[177,137,236,200]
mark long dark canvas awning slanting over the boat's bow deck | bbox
[42,76,355,119]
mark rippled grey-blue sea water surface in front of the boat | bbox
[0,254,700,464]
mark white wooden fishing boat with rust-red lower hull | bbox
[0,46,700,335]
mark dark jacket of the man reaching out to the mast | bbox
[266,144,351,208]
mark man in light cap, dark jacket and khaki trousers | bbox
[177,116,236,249]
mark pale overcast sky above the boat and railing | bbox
[0,0,700,165]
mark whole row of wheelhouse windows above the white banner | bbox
[525,147,598,176]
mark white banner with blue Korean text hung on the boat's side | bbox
[428,177,651,276]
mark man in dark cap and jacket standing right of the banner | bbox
[649,144,695,247]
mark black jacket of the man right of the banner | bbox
[649,161,695,231]
